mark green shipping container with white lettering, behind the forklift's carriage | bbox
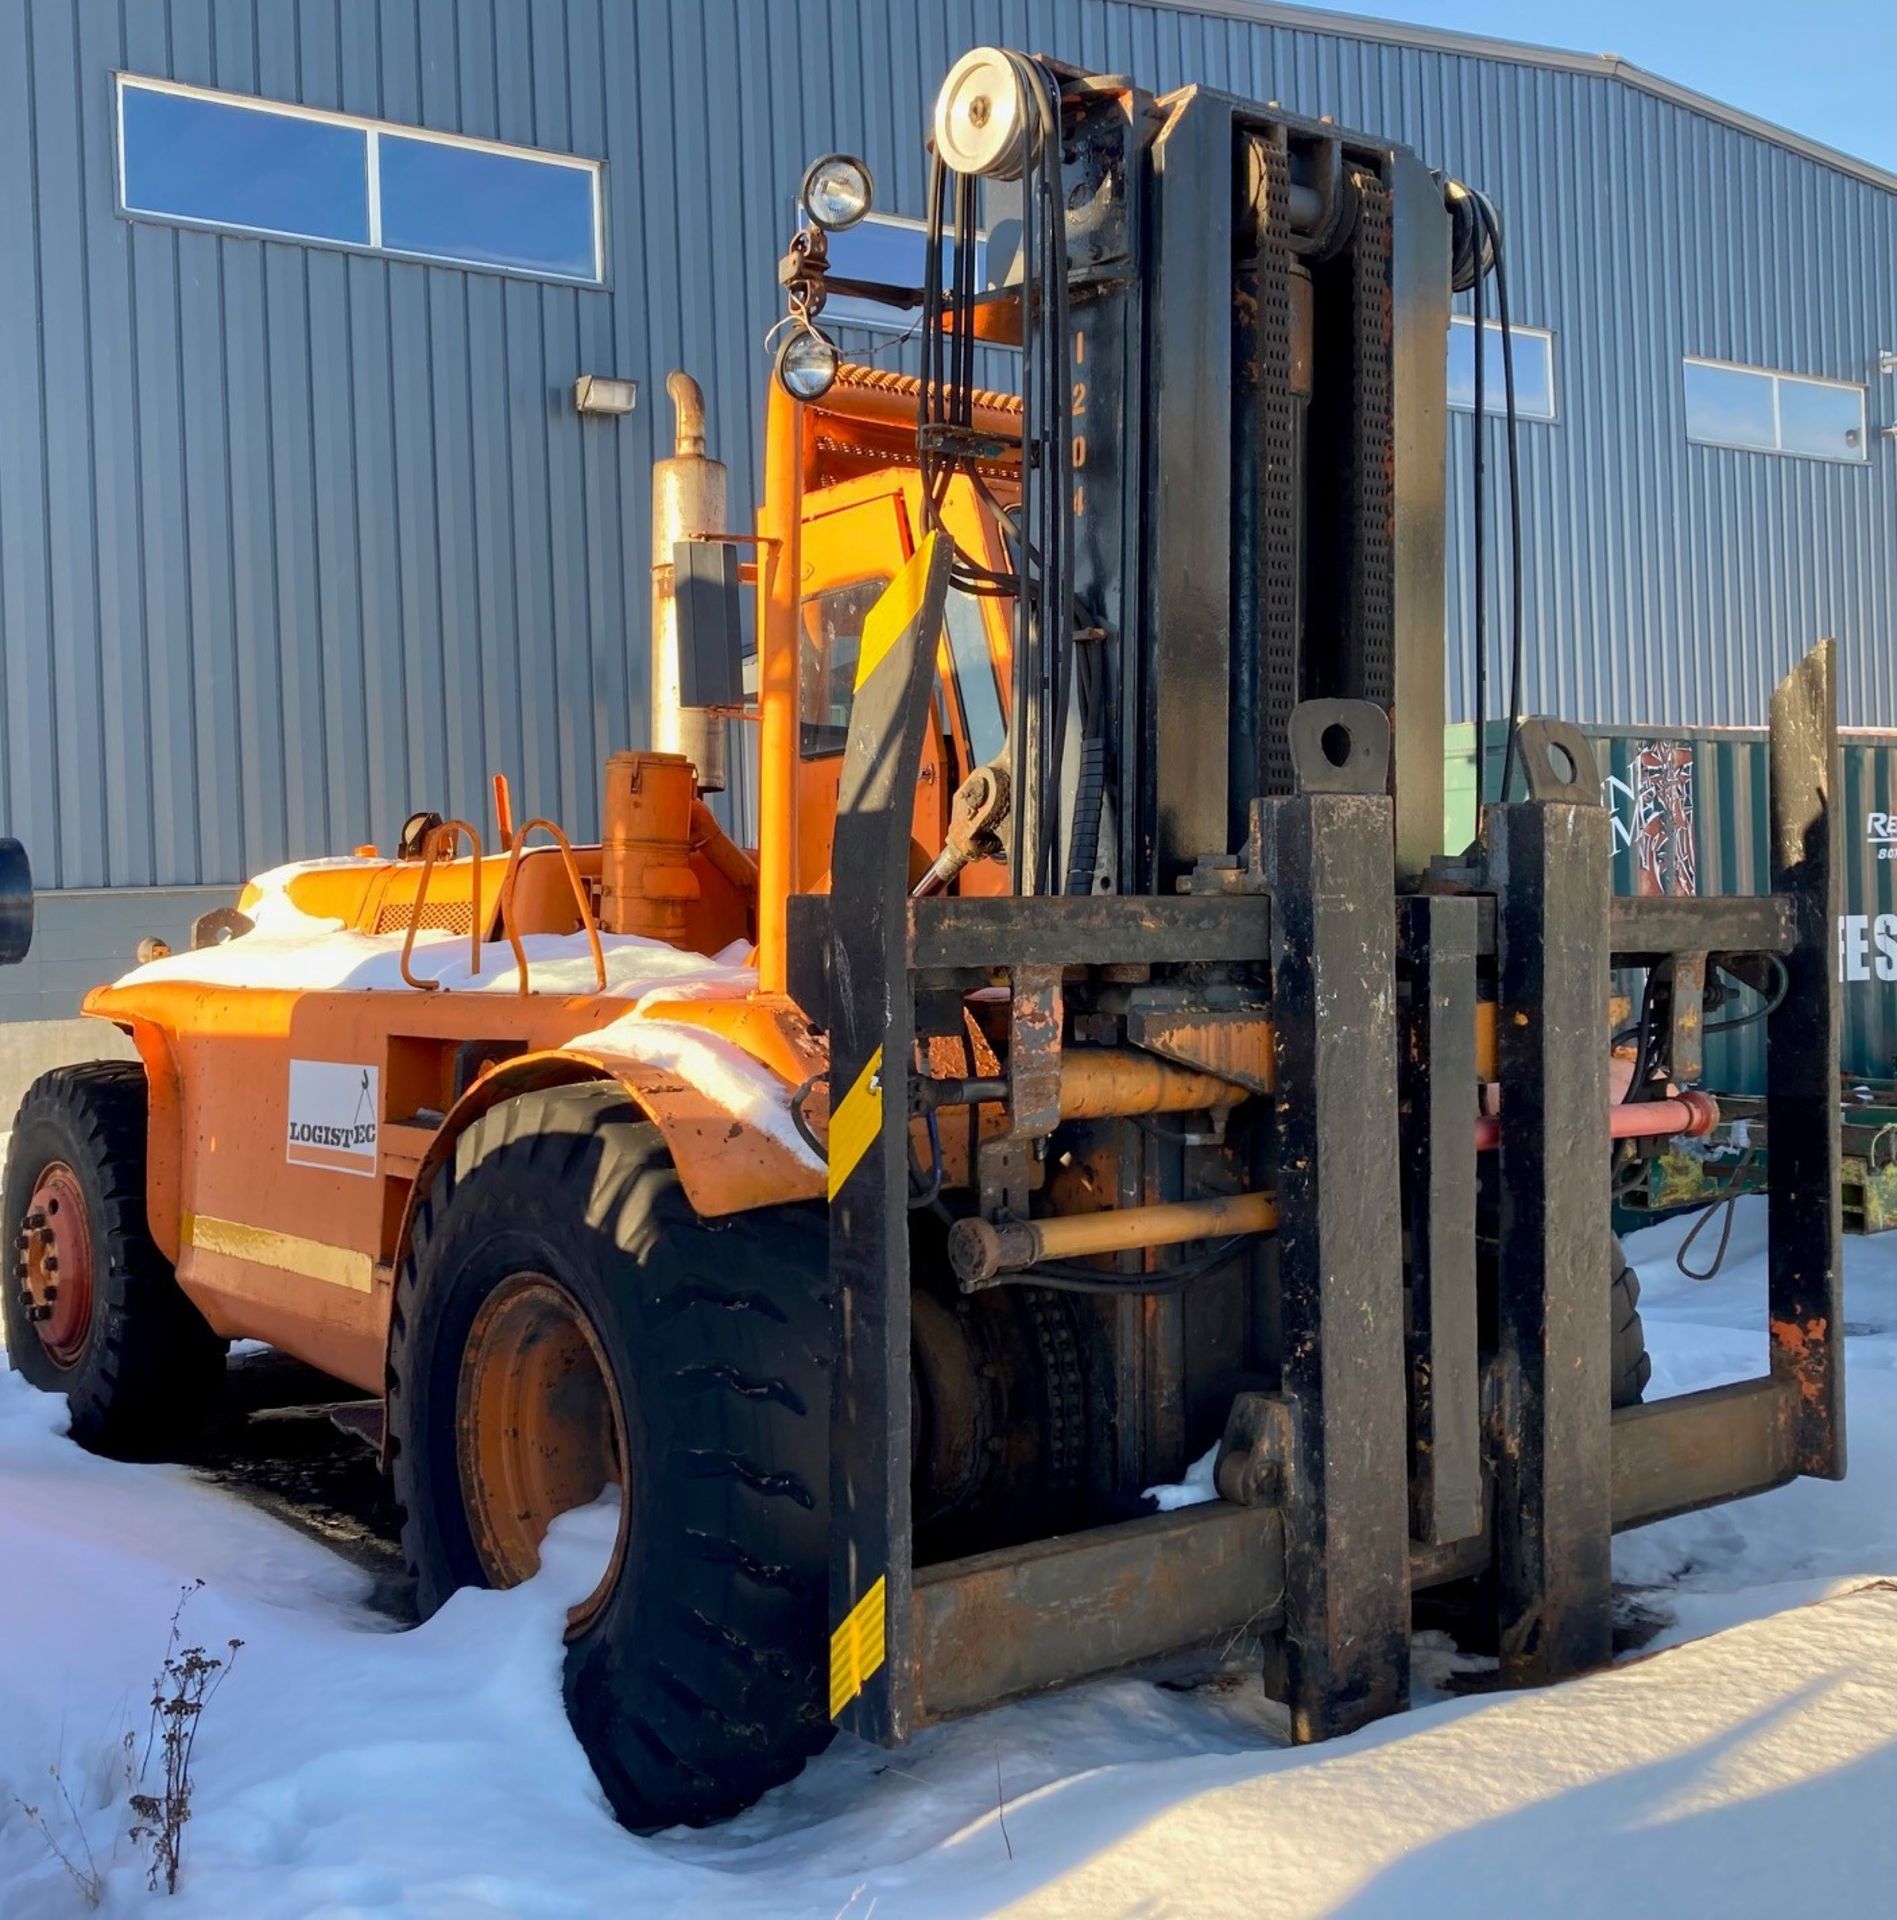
[1444,722,1897,1092]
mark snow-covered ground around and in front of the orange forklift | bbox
[0,1202,1897,1920]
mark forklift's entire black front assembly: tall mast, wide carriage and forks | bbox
[787,48,1843,1740]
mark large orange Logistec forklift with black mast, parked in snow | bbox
[4,48,1843,1828]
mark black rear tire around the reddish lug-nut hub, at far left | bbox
[0,1060,225,1459]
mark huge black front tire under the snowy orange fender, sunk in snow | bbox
[388,1087,835,1830]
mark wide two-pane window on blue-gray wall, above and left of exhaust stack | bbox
[119,73,605,284]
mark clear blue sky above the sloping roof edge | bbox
[1367,0,1897,173]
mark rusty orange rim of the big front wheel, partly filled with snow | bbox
[455,1273,630,1636]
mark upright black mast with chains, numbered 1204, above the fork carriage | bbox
[963,56,1452,895]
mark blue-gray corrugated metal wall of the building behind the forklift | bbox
[0,0,1897,1018]
